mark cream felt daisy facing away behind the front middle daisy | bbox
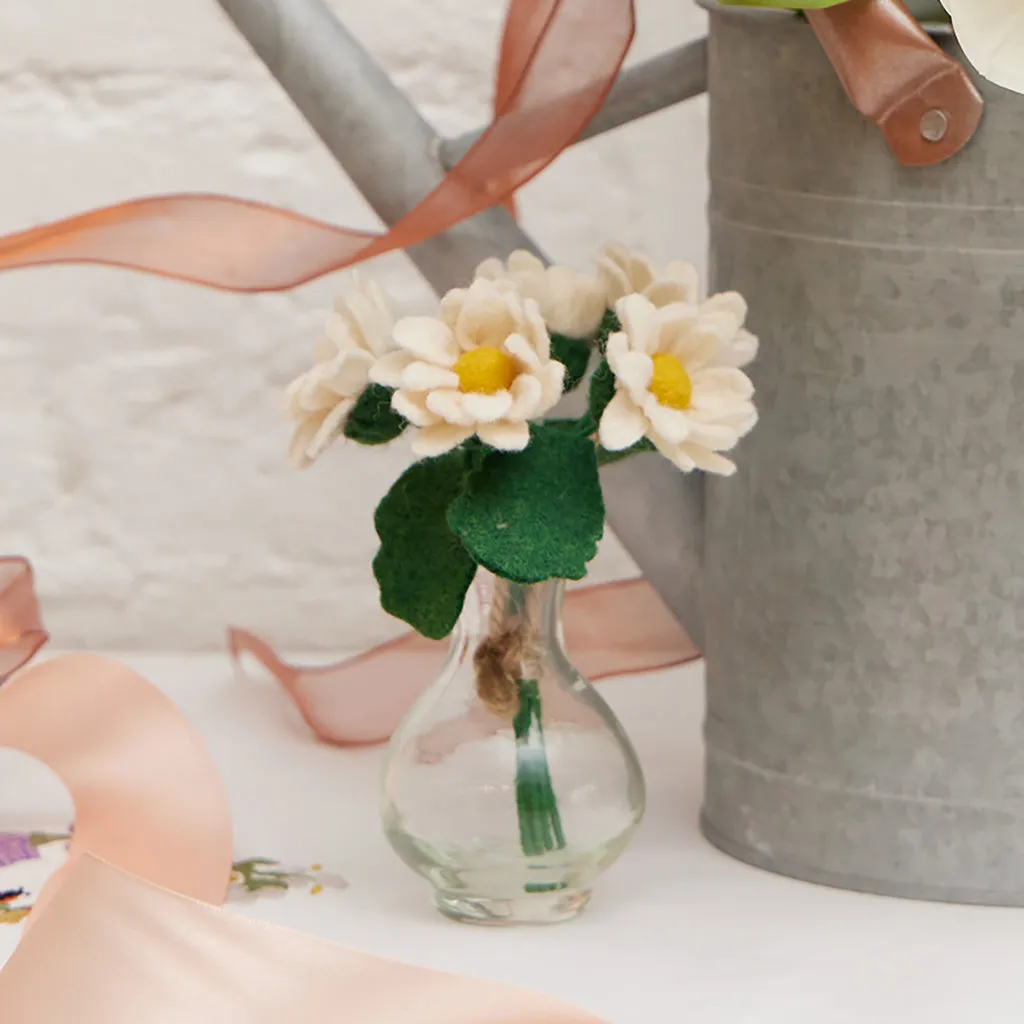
[476,249,605,338]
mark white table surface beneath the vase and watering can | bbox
[0,655,1024,1024]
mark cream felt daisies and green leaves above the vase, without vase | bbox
[287,246,757,639]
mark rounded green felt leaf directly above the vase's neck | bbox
[449,426,604,584]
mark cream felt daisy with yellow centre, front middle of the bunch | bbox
[371,278,565,456]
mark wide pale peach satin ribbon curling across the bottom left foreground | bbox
[0,655,597,1024]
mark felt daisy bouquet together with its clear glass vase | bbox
[287,246,758,923]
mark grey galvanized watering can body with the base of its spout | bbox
[608,9,1024,904]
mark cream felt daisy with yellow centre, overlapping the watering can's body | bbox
[599,294,757,475]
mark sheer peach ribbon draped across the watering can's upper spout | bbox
[0,0,635,292]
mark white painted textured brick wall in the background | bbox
[0,0,706,648]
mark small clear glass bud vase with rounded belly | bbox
[382,573,645,925]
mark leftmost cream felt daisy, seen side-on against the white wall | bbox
[285,281,394,469]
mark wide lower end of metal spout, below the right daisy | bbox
[601,453,707,649]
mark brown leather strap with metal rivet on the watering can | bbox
[806,0,984,167]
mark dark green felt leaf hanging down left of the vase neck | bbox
[374,451,476,640]
